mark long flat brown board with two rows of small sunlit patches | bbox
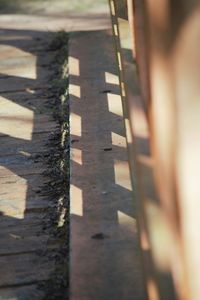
[69,30,145,300]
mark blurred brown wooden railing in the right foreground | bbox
[110,0,200,300]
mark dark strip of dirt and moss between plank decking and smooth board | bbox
[37,31,69,300]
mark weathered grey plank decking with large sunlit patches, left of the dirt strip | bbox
[0,17,63,300]
